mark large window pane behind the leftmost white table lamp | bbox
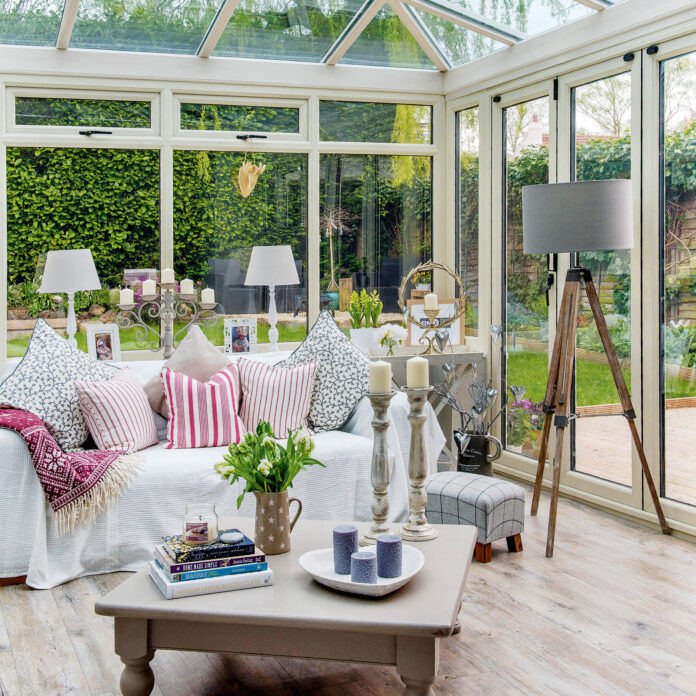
[7,147,160,357]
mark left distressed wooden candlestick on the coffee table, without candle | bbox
[360,391,395,546]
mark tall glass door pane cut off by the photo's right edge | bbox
[661,52,696,505]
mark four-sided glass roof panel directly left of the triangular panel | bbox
[213,0,362,63]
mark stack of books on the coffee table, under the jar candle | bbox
[150,529,273,599]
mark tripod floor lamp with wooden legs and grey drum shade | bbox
[522,179,671,558]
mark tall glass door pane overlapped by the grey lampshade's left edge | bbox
[503,97,549,457]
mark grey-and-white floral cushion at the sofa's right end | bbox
[279,310,370,432]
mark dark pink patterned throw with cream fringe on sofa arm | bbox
[0,409,142,532]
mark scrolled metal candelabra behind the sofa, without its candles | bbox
[116,283,218,359]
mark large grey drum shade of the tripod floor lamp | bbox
[522,179,633,254]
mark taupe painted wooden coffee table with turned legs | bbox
[95,518,477,696]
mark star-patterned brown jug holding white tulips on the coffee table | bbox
[215,421,324,555]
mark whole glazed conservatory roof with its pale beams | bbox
[0,0,622,70]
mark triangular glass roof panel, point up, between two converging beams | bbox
[340,5,436,70]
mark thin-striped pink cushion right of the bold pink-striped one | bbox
[238,359,319,439]
